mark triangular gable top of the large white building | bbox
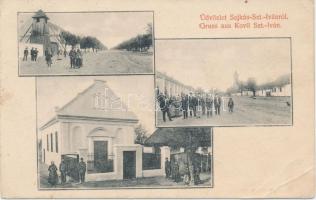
[40,80,138,129]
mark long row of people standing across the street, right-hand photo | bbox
[157,92,234,122]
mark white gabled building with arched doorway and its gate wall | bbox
[40,80,168,181]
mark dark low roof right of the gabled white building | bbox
[145,127,212,147]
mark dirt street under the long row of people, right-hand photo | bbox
[156,96,292,126]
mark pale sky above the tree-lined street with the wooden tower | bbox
[18,12,153,48]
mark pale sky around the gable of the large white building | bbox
[37,75,155,134]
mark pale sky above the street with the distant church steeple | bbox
[155,39,291,91]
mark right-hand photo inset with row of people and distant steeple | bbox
[155,38,293,127]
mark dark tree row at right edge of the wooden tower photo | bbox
[114,23,153,51]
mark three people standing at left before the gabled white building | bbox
[48,158,87,186]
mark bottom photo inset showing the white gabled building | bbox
[36,76,213,190]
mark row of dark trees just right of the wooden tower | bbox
[60,31,107,51]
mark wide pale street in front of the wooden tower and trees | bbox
[19,50,153,76]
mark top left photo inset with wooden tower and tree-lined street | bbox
[17,10,154,76]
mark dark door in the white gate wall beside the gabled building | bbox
[123,151,136,179]
